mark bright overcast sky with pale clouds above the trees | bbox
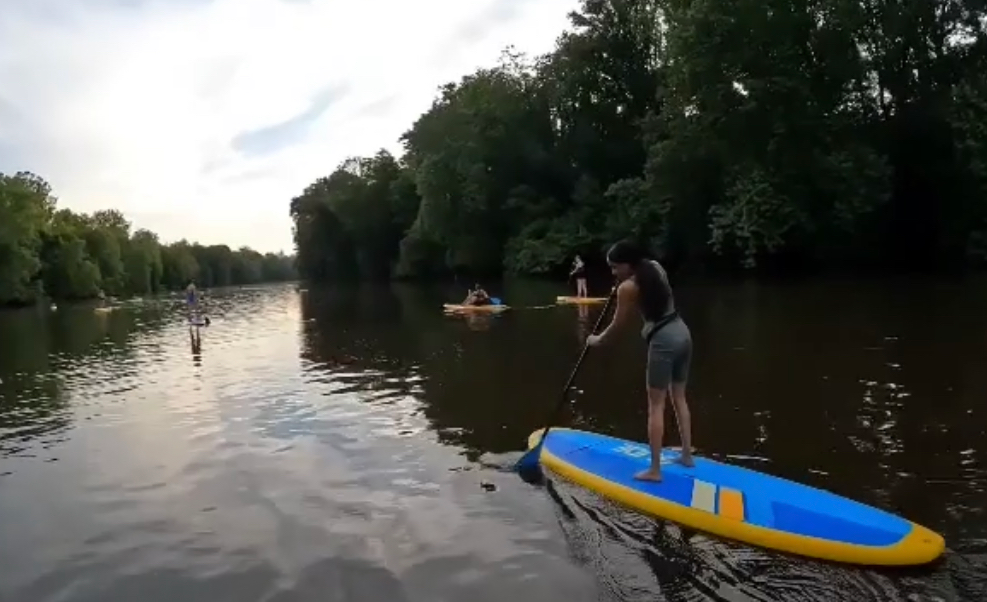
[0,0,578,252]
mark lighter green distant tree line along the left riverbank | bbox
[0,172,296,305]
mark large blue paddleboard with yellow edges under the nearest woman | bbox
[528,428,945,566]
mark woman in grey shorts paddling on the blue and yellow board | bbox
[586,241,693,481]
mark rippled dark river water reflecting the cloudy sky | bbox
[0,279,987,602]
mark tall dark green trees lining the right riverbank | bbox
[290,0,987,280]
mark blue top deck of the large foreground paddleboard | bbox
[532,428,943,564]
